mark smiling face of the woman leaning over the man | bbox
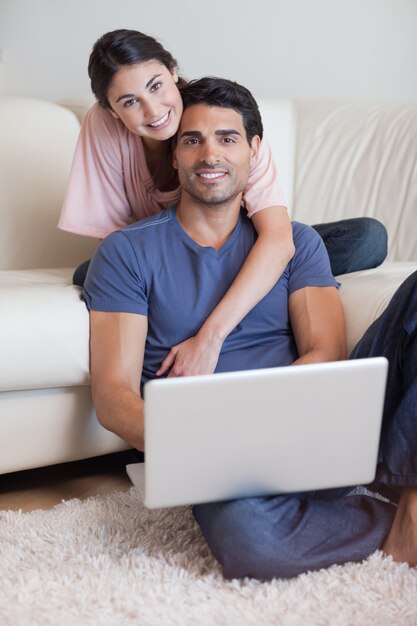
[107,60,182,141]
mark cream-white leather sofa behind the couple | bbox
[0,97,417,473]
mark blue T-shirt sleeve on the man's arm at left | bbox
[83,231,148,315]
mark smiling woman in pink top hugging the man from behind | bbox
[59,30,385,376]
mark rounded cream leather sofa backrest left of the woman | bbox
[0,97,97,270]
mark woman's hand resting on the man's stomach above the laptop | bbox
[156,332,223,377]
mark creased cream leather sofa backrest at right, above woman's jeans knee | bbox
[261,101,417,261]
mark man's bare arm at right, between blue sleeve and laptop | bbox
[289,287,346,365]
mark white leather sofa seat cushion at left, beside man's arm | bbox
[0,269,90,391]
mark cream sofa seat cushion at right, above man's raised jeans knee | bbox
[337,262,417,352]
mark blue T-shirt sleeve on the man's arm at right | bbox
[288,222,339,294]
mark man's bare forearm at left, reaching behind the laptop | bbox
[93,385,144,450]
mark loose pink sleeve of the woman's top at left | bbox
[58,104,132,239]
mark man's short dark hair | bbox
[180,76,263,144]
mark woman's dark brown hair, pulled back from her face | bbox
[88,29,186,109]
